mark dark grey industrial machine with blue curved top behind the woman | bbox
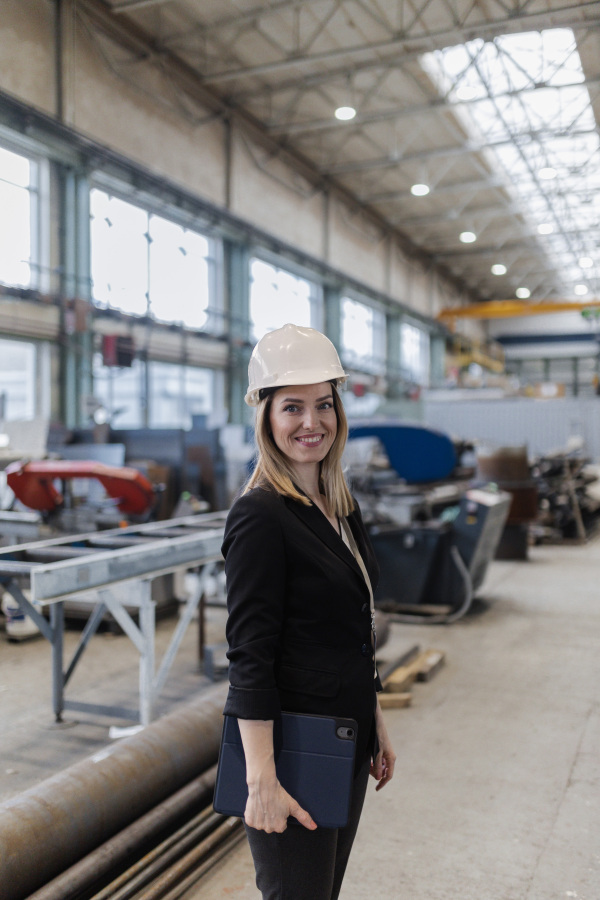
[348,421,511,623]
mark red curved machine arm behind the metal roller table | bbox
[6,459,154,516]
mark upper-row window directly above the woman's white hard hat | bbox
[250,259,323,341]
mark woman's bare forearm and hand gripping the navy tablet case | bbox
[238,719,317,833]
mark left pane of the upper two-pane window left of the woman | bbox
[90,190,148,315]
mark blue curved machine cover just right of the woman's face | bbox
[348,420,456,483]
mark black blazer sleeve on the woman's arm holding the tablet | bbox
[222,488,286,719]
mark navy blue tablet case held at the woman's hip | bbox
[213,712,358,828]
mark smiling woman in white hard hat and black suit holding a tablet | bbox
[223,325,395,900]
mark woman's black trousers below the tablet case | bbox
[246,755,371,900]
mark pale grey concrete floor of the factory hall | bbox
[0,541,600,900]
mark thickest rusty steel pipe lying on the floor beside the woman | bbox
[0,683,227,900]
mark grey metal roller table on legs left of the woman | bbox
[0,512,227,725]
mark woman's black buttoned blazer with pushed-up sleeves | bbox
[222,488,380,761]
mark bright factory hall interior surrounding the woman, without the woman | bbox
[0,0,600,900]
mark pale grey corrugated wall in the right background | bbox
[423,397,600,462]
